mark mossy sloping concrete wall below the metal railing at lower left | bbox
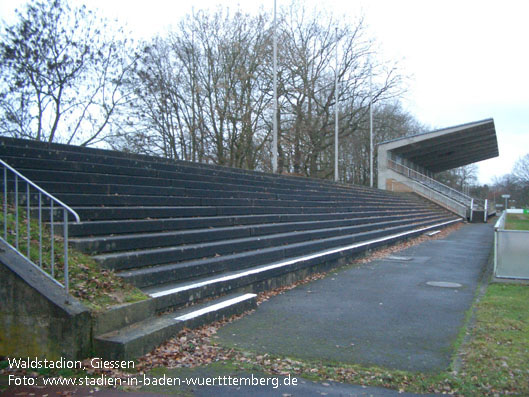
[0,241,91,359]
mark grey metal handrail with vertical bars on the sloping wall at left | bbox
[0,159,81,292]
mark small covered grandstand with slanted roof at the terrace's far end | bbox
[378,119,499,221]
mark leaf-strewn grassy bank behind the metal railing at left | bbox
[0,208,148,312]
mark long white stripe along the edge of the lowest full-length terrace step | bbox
[150,219,460,298]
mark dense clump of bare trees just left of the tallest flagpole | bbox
[115,11,270,168]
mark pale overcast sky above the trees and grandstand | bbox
[0,0,529,183]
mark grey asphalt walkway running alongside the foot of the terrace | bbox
[218,224,493,372]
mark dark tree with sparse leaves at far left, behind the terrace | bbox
[0,0,134,145]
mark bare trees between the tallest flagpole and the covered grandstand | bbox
[272,3,402,179]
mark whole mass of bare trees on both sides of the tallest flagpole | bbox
[113,3,412,183]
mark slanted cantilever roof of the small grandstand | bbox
[379,119,499,173]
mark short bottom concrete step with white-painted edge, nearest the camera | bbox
[94,293,257,360]
